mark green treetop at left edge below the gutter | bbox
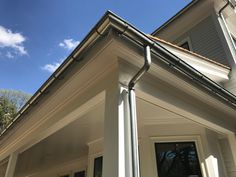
[0,89,31,132]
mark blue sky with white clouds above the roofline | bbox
[0,0,191,94]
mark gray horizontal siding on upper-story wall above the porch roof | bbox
[174,16,229,66]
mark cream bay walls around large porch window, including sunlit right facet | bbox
[140,124,230,177]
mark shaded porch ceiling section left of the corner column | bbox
[16,103,104,176]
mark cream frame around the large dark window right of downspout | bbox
[150,135,207,177]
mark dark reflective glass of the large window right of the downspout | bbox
[155,142,202,177]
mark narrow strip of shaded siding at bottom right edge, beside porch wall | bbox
[220,139,236,177]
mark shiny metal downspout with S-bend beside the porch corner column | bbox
[128,46,151,177]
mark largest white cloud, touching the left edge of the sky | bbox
[0,26,27,56]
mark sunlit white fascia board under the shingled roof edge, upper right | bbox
[159,42,230,83]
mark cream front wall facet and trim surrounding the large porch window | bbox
[139,124,206,177]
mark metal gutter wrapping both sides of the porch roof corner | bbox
[0,11,236,139]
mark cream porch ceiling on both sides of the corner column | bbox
[12,94,195,175]
